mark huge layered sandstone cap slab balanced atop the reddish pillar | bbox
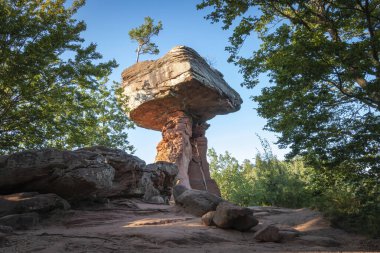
[122,46,242,131]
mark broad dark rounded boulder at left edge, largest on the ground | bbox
[0,149,115,201]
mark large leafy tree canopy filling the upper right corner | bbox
[197,0,380,174]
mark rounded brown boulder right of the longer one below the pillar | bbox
[213,202,258,231]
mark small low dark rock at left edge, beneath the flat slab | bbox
[0,213,39,229]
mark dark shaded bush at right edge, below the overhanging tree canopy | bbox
[310,167,380,237]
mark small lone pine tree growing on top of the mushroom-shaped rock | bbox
[129,17,162,62]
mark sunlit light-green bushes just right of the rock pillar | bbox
[208,140,311,208]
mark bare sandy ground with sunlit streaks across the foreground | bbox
[0,200,380,253]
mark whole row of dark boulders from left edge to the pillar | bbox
[0,146,177,204]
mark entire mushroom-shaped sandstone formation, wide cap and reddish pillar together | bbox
[122,46,242,195]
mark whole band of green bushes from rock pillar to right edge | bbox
[208,146,380,236]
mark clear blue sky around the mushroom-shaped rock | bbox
[76,0,286,163]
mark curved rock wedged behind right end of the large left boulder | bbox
[76,146,145,197]
